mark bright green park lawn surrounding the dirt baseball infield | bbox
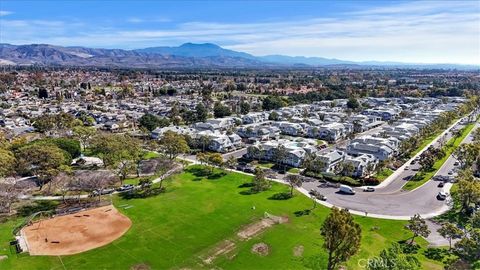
[0,166,440,270]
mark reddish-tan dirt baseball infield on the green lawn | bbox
[21,205,132,256]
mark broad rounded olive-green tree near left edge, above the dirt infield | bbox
[16,144,68,188]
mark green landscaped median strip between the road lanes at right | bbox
[403,123,475,191]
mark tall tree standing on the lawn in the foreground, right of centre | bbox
[320,207,362,270]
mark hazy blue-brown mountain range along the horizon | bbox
[0,43,479,69]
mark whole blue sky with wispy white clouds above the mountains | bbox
[0,0,480,64]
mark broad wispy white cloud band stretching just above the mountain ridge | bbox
[0,1,480,64]
